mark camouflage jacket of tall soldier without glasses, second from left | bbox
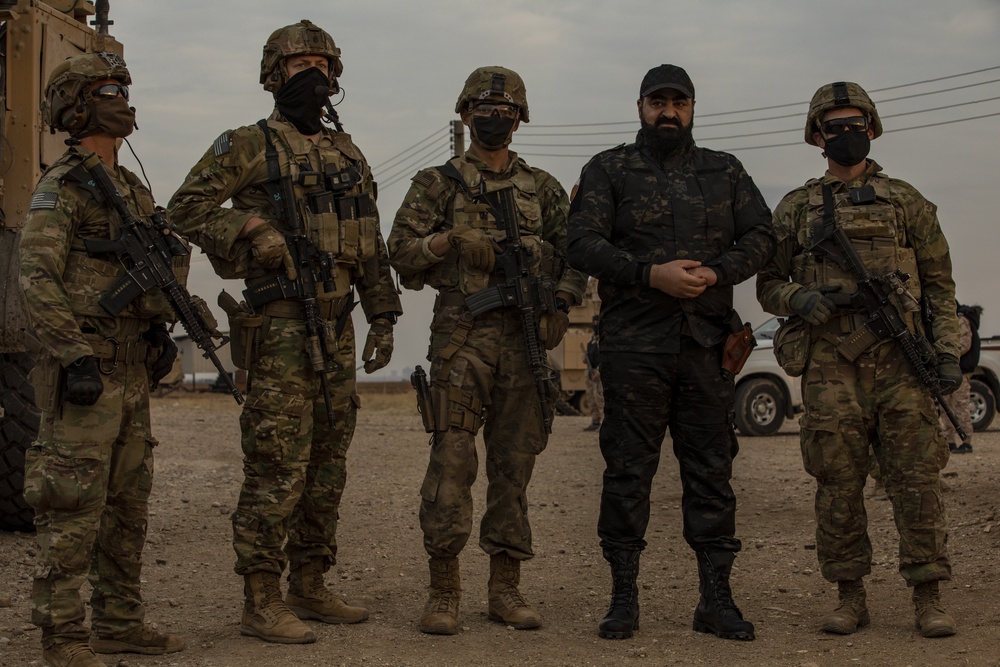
[169,111,402,319]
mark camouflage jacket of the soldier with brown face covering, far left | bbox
[20,147,176,366]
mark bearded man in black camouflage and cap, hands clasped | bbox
[568,65,774,640]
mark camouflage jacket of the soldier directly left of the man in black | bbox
[389,149,587,303]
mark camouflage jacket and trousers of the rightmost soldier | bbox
[757,160,959,586]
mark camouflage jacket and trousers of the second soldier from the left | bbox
[169,111,402,575]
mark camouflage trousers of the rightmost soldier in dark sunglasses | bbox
[800,339,951,586]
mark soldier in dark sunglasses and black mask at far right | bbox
[757,82,962,637]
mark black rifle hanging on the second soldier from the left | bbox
[243,120,346,428]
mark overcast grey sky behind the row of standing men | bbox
[103,0,1000,374]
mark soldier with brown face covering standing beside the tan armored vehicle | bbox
[20,53,186,667]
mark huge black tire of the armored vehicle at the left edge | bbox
[0,353,39,532]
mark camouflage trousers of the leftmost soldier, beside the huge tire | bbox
[24,363,156,647]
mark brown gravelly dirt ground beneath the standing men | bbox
[0,393,1000,667]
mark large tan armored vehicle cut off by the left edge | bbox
[0,0,123,530]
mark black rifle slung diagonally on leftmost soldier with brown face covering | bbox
[76,153,243,404]
